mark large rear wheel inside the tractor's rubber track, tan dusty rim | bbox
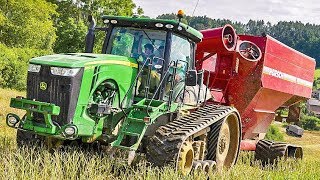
[207,113,241,169]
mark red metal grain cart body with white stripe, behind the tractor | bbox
[196,25,316,139]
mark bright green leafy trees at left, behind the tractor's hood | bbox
[0,0,139,90]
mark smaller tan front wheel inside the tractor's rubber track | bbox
[177,141,194,175]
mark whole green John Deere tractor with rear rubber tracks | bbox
[7,12,241,174]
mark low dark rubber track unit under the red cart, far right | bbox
[255,140,303,165]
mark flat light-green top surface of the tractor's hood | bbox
[30,53,138,68]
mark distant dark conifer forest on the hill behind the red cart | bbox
[157,13,320,67]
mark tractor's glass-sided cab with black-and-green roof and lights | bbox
[86,16,202,104]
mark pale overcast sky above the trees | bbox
[133,0,320,24]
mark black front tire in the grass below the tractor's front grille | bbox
[16,129,45,148]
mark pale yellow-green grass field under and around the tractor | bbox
[0,89,320,180]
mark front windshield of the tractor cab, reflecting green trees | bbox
[108,27,167,61]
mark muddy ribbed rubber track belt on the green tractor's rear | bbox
[146,105,237,166]
